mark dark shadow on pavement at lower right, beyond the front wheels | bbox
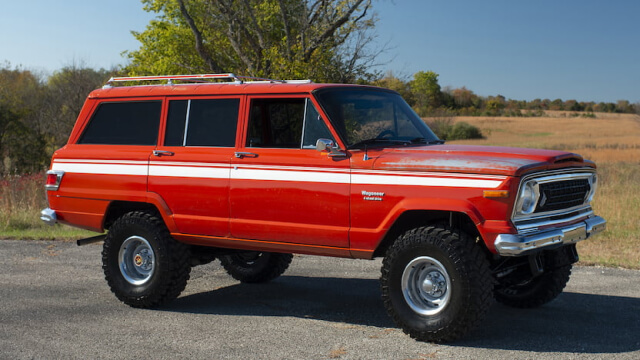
[460,292,640,354]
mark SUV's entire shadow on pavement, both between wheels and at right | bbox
[161,276,640,353]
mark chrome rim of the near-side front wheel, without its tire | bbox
[402,256,451,315]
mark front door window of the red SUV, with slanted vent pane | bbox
[246,98,333,149]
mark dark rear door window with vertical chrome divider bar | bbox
[164,99,240,147]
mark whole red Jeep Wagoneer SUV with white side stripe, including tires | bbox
[42,74,606,341]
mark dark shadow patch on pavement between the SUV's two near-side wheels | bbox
[162,276,395,328]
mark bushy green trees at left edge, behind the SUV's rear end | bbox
[0,64,110,175]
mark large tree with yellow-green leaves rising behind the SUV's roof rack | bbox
[126,0,377,82]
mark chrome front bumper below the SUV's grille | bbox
[494,216,607,256]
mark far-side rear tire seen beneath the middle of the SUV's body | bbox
[219,251,293,283]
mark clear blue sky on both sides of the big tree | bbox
[0,0,640,103]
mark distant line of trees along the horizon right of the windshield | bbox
[371,71,640,117]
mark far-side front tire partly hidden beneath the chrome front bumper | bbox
[495,265,572,309]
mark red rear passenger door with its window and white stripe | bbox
[149,96,242,237]
